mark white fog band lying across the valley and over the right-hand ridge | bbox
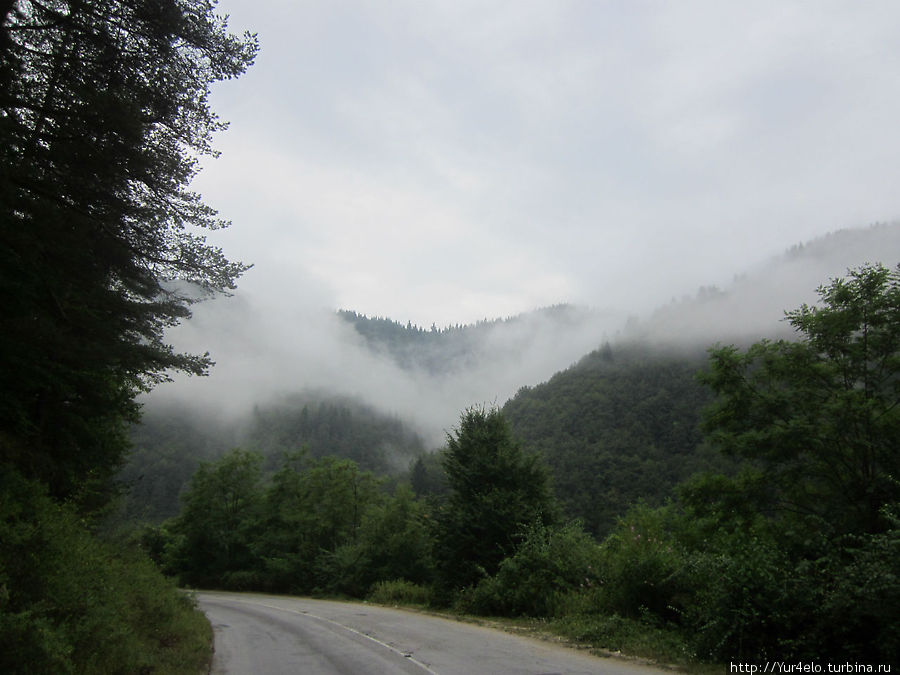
[144,225,900,446]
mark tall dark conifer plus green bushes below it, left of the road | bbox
[0,0,256,674]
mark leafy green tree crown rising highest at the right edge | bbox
[699,265,900,534]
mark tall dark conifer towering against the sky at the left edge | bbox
[0,0,256,502]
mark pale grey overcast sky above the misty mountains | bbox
[195,0,900,327]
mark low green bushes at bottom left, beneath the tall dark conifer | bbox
[0,470,212,674]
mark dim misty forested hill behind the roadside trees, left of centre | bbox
[119,392,426,521]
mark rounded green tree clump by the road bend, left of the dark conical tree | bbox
[149,450,432,597]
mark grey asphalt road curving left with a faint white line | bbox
[197,592,665,675]
